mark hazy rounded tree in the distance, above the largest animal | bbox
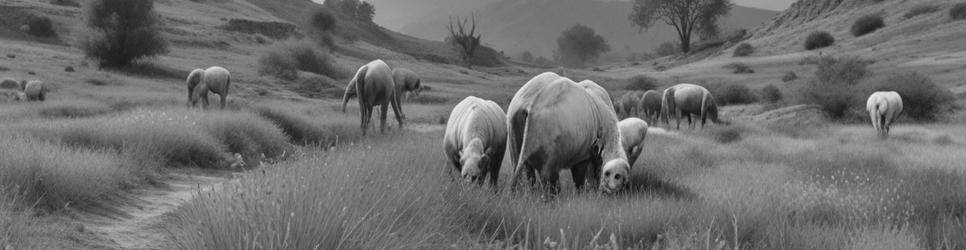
[557,24,610,67]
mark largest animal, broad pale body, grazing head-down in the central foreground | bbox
[507,72,630,194]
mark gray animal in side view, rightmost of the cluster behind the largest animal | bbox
[661,83,726,129]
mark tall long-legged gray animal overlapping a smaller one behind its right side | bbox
[342,60,403,135]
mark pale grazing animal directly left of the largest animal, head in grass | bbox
[443,96,506,188]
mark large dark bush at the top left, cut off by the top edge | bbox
[80,0,168,67]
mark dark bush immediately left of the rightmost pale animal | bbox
[802,57,869,119]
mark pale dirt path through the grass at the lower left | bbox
[78,173,229,249]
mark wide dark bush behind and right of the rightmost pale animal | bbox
[871,72,958,121]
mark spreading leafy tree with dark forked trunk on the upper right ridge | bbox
[628,0,731,53]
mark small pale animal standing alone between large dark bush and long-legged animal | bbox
[186,66,231,109]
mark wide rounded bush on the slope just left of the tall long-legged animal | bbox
[258,41,344,80]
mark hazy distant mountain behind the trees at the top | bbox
[398,0,778,57]
